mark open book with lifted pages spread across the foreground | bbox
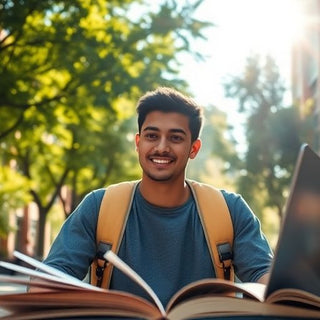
[0,251,320,320]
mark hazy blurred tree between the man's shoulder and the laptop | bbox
[225,56,312,219]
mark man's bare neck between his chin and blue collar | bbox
[140,178,190,208]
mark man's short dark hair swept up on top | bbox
[137,87,203,142]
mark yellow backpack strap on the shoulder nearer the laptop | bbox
[187,180,234,281]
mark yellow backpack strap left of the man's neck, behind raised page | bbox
[91,181,138,288]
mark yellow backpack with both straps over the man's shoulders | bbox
[90,180,234,288]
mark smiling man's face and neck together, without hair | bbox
[136,111,201,207]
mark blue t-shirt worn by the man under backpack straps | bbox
[45,184,272,305]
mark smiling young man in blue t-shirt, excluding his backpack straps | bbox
[45,88,272,305]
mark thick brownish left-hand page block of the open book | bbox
[0,288,161,319]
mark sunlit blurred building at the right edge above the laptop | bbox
[292,0,320,152]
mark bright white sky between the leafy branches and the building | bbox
[181,0,301,110]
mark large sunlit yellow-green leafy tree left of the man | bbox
[0,0,210,256]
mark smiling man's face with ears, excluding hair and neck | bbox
[136,111,201,181]
